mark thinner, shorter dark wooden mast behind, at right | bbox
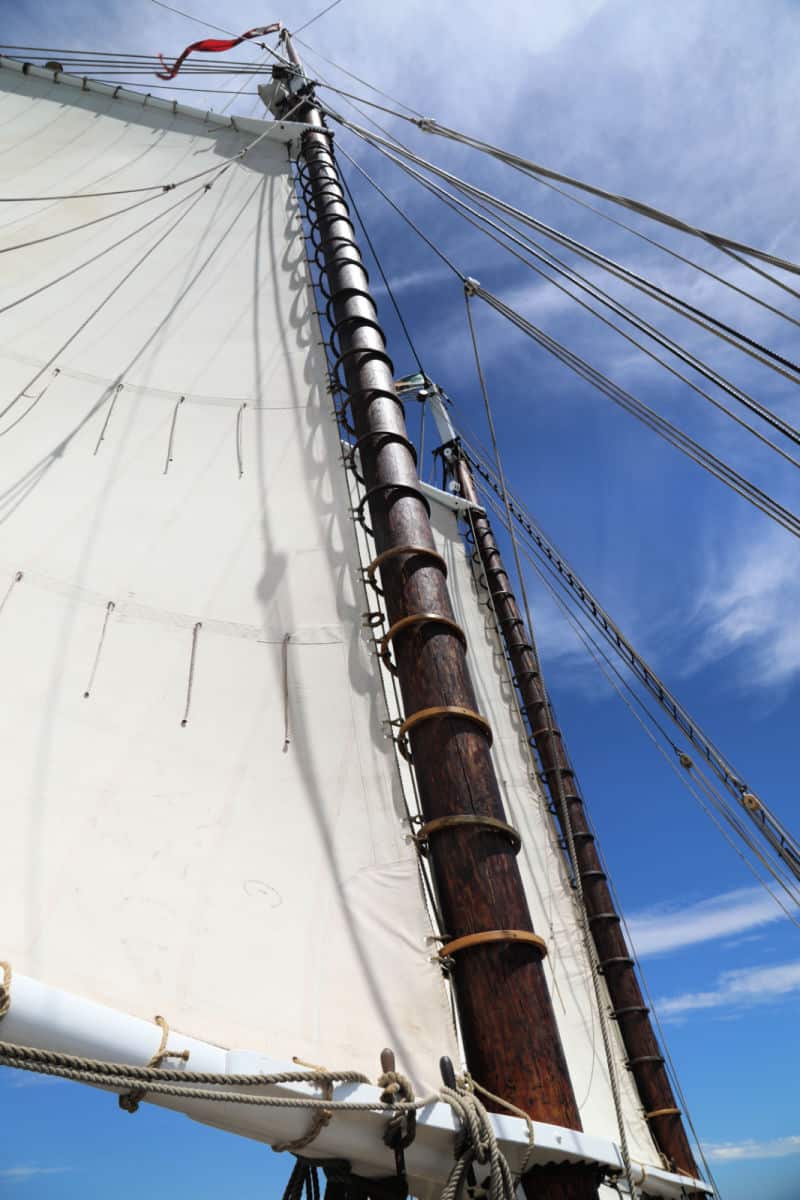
[455,455,697,1177]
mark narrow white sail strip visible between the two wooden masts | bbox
[434,505,661,1164]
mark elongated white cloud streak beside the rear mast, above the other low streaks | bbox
[628,888,783,956]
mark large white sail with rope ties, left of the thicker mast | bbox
[0,67,457,1087]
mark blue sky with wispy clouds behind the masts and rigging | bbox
[0,0,800,1200]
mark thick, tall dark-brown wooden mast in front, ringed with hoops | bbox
[284,36,597,1200]
